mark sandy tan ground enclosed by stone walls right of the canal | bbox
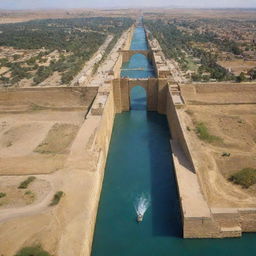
[179,85,256,208]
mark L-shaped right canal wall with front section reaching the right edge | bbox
[166,85,256,238]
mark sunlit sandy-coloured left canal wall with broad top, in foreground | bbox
[58,83,116,256]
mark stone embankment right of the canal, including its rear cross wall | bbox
[166,84,256,238]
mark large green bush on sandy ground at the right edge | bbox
[229,168,256,188]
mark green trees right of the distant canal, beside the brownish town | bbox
[145,20,235,81]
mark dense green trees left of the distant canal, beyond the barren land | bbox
[0,17,133,85]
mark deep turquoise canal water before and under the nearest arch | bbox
[92,26,256,256]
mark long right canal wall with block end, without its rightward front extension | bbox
[166,86,224,238]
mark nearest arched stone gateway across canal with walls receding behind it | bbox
[112,27,171,114]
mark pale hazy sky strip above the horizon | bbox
[0,0,256,9]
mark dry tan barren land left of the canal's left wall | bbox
[0,87,97,256]
